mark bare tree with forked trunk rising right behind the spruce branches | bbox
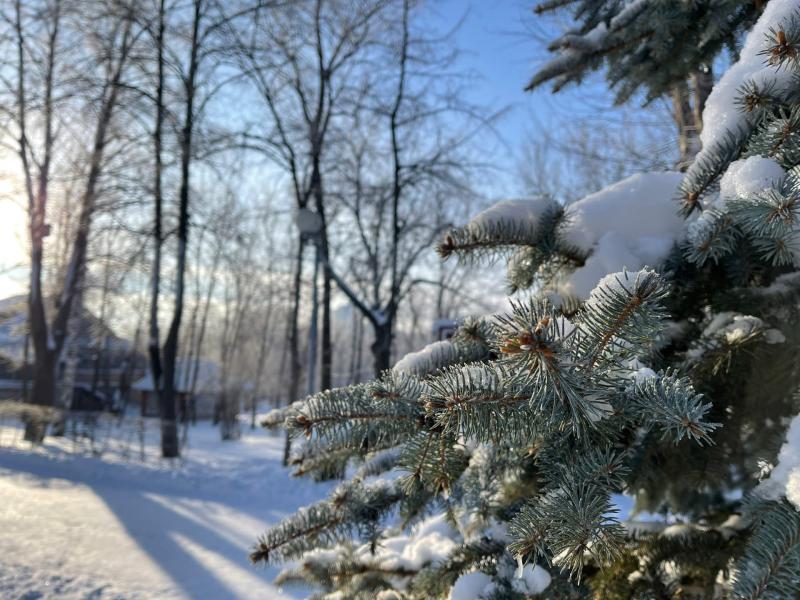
[324,0,491,375]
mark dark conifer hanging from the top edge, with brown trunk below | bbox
[527,0,766,170]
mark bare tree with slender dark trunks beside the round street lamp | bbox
[235,0,390,408]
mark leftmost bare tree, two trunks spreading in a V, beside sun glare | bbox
[0,0,141,441]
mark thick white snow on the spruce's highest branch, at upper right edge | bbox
[700,0,797,149]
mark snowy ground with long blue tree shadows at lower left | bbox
[0,424,331,600]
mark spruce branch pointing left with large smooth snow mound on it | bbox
[439,172,685,303]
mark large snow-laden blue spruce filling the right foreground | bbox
[252,0,800,600]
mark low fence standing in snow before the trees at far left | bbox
[0,401,180,462]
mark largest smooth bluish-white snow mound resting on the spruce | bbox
[556,171,685,300]
